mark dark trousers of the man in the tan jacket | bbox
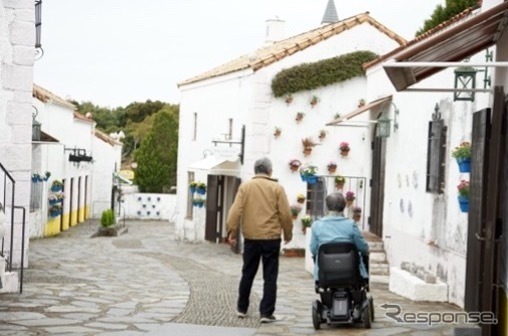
[237,239,281,316]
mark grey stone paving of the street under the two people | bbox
[0,221,480,336]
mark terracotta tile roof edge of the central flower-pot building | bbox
[178,12,407,87]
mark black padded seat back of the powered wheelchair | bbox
[318,243,361,287]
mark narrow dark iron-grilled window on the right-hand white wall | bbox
[425,111,447,194]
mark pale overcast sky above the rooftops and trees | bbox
[34,0,445,108]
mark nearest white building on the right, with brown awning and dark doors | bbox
[334,1,508,335]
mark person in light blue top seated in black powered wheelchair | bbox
[310,192,373,329]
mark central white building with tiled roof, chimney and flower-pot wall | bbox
[176,8,405,248]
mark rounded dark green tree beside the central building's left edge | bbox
[134,107,178,193]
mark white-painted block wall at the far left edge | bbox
[0,0,35,267]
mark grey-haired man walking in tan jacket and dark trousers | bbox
[227,158,293,323]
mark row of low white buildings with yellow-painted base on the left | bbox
[31,85,122,237]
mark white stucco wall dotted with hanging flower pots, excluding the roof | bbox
[175,19,397,243]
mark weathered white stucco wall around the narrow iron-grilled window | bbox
[368,45,492,306]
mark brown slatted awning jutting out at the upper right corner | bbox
[383,2,508,91]
